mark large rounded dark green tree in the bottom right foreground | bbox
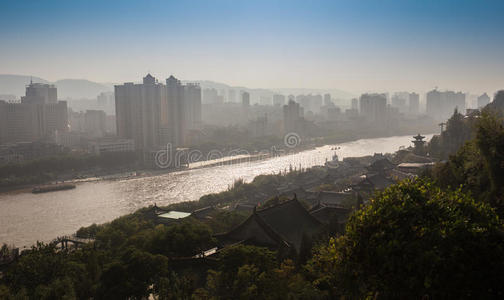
[307,179,504,299]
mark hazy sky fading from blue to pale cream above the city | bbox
[0,0,504,93]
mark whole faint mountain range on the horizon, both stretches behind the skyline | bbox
[0,74,355,101]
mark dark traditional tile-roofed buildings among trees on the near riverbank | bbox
[146,135,433,262]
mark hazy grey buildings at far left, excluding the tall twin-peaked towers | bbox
[0,82,123,163]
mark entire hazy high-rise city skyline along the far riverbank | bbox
[0,74,496,166]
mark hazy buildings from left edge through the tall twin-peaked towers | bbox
[0,74,202,163]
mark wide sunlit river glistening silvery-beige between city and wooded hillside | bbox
[0,135,432,246]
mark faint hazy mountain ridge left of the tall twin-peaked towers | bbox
[0,74,112,99]
